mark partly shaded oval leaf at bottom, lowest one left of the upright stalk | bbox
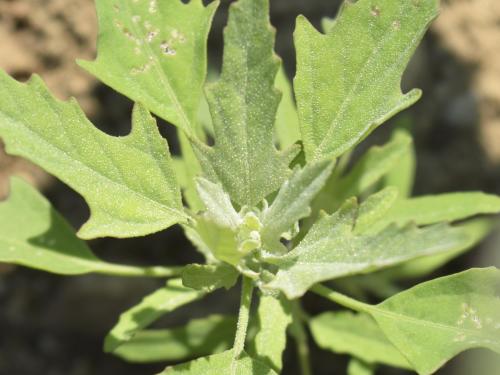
[113,315,236,363]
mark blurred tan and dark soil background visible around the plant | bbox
[0,0,500,375]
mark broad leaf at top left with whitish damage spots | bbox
[79,0,218,136]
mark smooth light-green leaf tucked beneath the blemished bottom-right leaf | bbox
[309,312,411,369]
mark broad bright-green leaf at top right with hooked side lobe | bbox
[294,0,438,160]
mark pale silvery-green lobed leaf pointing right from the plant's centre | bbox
[265,199,465,299]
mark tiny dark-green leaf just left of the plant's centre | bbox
[182,263,239,292]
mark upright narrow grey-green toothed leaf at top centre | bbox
[193,0,295,206]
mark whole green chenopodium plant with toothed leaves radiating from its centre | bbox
[0,0,500,375]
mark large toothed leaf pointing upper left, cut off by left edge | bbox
[0,72,187,238]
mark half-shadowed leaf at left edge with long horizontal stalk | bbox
[0,178,180,276]
